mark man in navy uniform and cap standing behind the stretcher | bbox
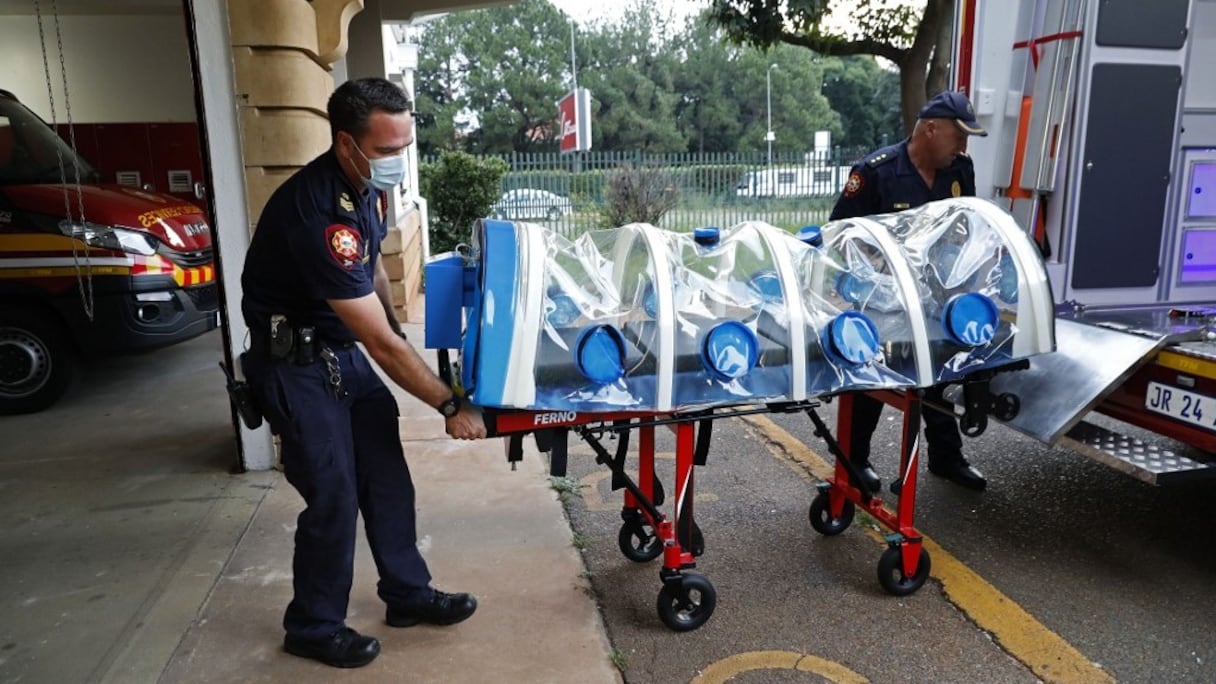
[831,91,987,490]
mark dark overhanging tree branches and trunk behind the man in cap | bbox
[708,0,955,133]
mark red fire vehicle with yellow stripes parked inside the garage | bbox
[0,90,219,414]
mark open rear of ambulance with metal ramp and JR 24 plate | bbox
[953,0,1216,484]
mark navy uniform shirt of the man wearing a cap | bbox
[829,140,975,220]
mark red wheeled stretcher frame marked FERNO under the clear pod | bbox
[483,389,1006,632]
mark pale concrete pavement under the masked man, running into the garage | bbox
[0,318,620,684]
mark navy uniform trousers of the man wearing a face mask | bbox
[243,347,430,638]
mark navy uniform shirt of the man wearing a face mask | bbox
[241,150,388,344]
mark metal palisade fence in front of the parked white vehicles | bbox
[422,147,868,237]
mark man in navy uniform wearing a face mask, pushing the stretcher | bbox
[241,78,485,667]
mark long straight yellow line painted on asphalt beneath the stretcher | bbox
[744,415,1115,684]
